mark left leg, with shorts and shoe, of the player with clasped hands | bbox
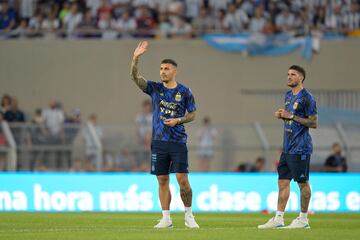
[258,153,292,229]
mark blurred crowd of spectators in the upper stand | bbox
[0,0,360,39]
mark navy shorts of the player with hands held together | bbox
[277,153,310,183]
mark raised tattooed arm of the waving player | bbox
[130,41,148,91]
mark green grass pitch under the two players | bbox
[0,212,360,240]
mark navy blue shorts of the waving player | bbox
[150,141,189,176]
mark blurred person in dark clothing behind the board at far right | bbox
[324,143,348,172]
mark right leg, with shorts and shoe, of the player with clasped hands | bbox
[286,155,311,228]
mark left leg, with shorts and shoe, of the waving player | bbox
[151,142,172,228]
